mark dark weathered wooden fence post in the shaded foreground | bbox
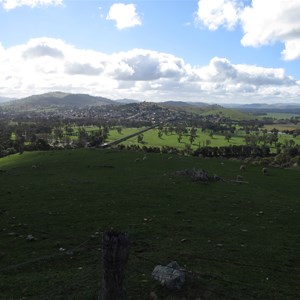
[99,231,129,300]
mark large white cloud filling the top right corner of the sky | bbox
[240,0,300,60]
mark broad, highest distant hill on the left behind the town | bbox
[5,92,117,110]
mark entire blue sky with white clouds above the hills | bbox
[0,0,300,104]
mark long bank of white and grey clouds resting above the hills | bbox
[0,37,300,102]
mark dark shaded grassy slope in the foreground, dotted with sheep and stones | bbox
[0,150,300,300]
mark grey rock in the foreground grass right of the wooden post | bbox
[152,261,185,291]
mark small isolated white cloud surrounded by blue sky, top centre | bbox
[106,3,142,29]
